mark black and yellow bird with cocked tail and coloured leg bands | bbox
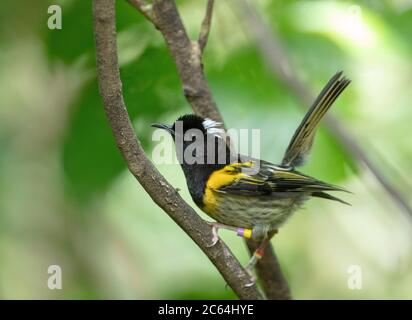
[152,71,351,284]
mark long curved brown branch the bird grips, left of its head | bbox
[93,0,262,299]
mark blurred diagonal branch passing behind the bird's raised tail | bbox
[235,0,412,217]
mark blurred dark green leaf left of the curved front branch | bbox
[63,80,124,200]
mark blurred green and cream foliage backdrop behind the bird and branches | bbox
[0,0,412,299]
